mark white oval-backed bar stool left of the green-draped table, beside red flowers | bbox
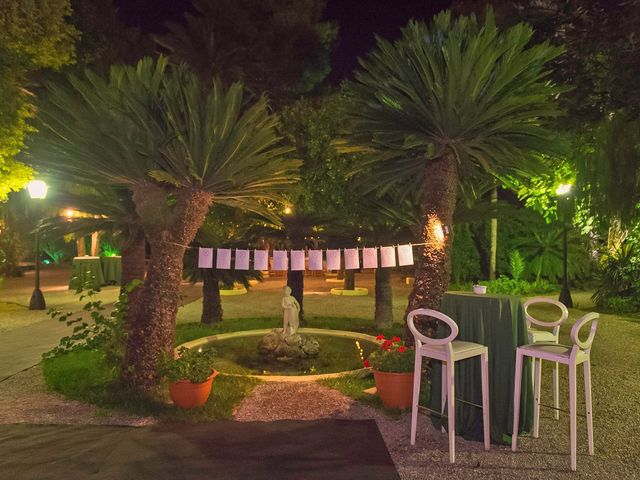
[407,308,491,463]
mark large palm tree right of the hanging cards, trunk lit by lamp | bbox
[350,10,562,338]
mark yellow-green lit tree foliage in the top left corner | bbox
[0,0,77,201]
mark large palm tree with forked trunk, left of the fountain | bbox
[31,58,298,390]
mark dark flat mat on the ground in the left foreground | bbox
[0,420,399,480]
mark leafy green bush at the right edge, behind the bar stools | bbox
[592,242,640,313]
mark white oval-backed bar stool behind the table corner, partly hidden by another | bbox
[524,297,569,420]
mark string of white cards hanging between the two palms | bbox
[198,243,436,271]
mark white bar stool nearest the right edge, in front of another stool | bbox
[511,313,599,471]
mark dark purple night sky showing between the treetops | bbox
[115,0,451,79]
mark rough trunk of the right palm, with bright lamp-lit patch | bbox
[405,153,458,343]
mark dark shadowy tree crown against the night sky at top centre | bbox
[156,0,337,103]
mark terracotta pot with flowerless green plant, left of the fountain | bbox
[160,347,218,408]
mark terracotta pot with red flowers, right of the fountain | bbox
[365,335,414,409]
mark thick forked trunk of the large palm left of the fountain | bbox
[122,183,213,391]
